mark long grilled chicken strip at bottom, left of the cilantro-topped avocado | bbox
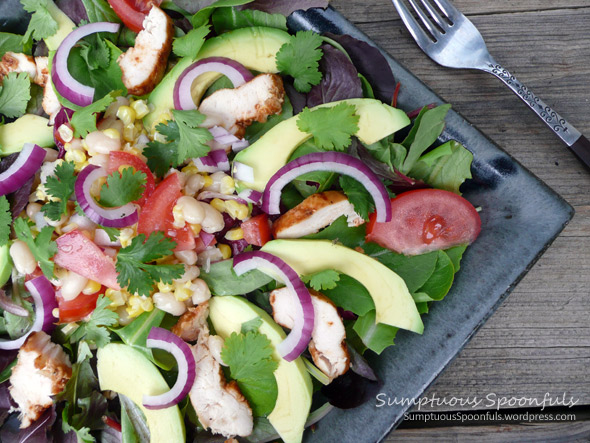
[189,303,254,438]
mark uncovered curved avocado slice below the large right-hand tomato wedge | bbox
[262,240,424,334]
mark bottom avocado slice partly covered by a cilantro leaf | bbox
[209,296,312,443]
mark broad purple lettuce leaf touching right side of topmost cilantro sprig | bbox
[307,44,363,108]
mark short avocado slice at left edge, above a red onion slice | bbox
[0,114,55,157]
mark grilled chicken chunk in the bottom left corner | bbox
[9,332,72,428]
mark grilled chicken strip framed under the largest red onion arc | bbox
[272,191,364,238]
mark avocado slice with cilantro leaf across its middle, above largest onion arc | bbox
[235,98,410,191]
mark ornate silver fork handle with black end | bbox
[483,61,590,168]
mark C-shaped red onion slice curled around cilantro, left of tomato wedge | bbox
[74,165,139,228]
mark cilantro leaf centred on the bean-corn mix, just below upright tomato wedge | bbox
[115,231,184,295]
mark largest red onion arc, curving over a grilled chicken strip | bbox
[262,151,392,223]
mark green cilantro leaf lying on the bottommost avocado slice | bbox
[221,331,278,416]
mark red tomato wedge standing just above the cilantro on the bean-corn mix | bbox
[137,174,195,251]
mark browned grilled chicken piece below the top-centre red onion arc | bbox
[199,74,285,138]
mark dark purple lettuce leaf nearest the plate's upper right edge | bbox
[326,33,396,103]
